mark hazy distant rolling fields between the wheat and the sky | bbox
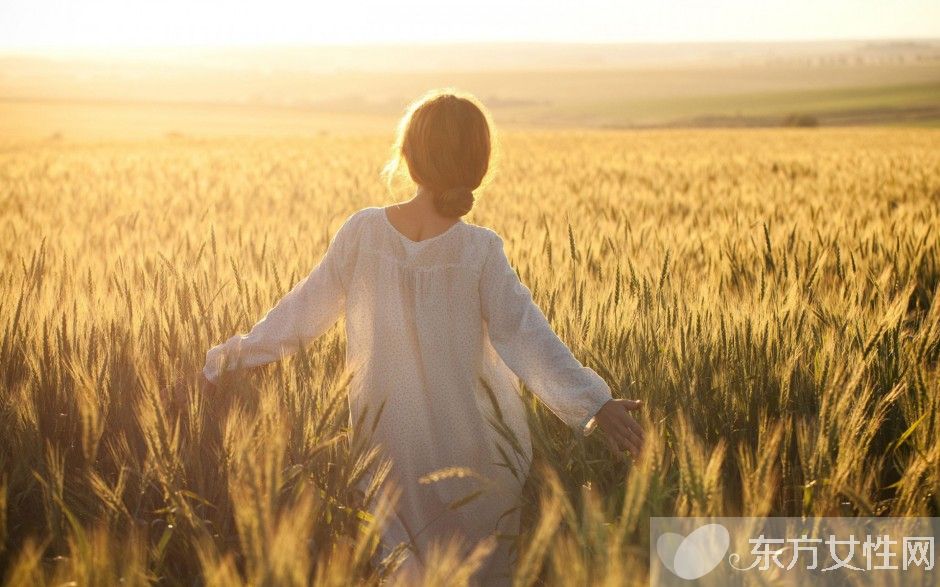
[0,41,940,139]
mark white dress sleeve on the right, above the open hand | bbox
[480,233,611,435]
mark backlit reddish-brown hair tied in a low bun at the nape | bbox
[382,88,496,218]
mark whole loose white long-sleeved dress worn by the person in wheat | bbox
[203,207,611,585]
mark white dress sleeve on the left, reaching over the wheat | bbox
[203,217,352,382]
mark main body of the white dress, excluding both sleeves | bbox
[345,208,531,584]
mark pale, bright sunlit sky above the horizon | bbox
[0,0,940,50]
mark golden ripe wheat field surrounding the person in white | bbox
[0,129,940,586]
